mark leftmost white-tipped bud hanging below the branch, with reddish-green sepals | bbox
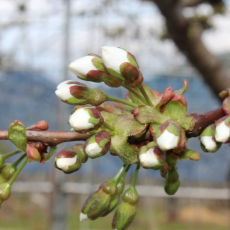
[54,148,81,174]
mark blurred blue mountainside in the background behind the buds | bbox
[0,72,230,182]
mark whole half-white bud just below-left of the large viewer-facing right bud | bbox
[139,146,166,170]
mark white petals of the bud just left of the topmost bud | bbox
[69,56,97,77]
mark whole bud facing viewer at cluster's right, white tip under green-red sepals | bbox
[155,122,185,151]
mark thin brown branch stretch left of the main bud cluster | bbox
[0,130,90,146]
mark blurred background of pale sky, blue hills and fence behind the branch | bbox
[0,0,230,230]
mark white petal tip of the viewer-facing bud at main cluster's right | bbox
[157,129,179,150]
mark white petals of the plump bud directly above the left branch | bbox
[69,108,94,130]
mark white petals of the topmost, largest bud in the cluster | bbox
[101,46,129,73]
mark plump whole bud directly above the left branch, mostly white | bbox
[69,106,104,133]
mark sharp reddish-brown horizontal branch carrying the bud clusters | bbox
[0,108,225,146]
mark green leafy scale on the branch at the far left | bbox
[8,120,27,152]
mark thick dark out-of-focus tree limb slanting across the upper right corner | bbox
[153,0,230,98]
